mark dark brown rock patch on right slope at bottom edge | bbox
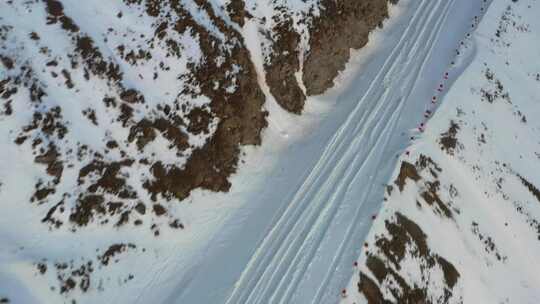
[358,213,459,304]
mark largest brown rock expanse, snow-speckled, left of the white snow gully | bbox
[14,0,267,229]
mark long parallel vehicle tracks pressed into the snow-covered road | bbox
[221,1,458,303]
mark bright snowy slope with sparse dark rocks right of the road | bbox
[342,0,540,304]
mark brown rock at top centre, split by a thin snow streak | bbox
[265,0,397,114]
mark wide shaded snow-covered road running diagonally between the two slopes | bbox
[150,0,487,304]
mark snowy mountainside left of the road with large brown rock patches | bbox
[0,0,396,303]
